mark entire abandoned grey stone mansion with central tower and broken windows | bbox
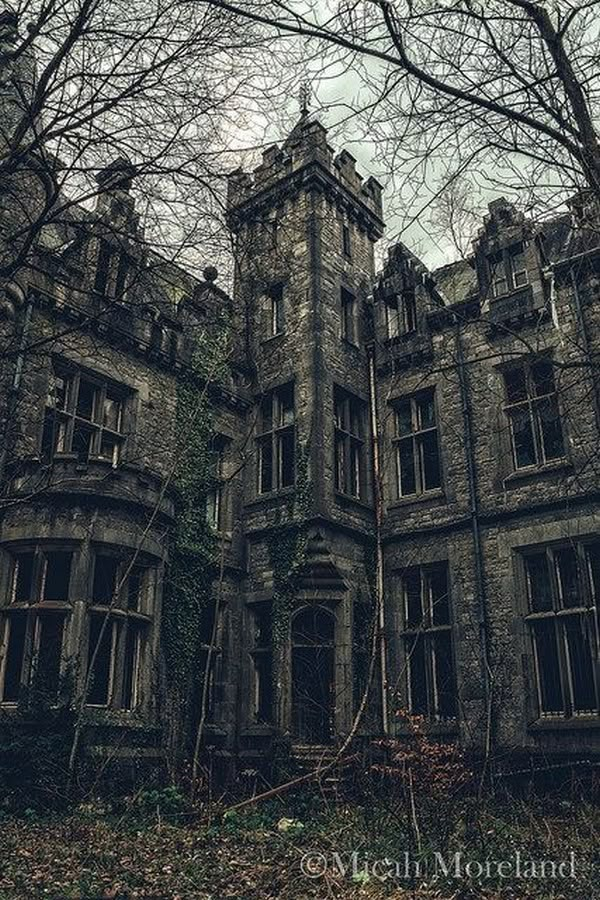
[0,102,600,758]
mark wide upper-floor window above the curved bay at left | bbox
[42,362,125,466]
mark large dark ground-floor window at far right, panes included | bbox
[523,542,600,717]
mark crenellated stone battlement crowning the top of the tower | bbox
[227,114,383,219]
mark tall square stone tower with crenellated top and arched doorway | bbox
[229,112,383,743]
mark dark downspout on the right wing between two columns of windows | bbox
[455,320,492,758]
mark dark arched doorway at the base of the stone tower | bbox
[292,605,335,744]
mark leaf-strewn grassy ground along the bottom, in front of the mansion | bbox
[0,790,600,900]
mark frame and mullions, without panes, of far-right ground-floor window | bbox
[518,537,600,722]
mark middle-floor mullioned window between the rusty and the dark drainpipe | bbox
[394,390,442,498]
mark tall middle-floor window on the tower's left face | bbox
[258,384,295,494]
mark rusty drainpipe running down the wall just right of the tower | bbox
[367,343,389,734]
